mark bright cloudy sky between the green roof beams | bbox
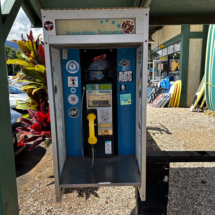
[0,0,43,41]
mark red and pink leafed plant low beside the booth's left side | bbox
[16,102,51,150]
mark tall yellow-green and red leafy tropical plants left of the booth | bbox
[7,31,51,150]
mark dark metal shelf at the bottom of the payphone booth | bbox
[60,155,141,188]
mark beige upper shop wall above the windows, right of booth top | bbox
[151,25,181,49]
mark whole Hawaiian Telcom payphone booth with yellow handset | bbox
[42,8,149,201]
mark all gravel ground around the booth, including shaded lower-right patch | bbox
[18,105,215,215]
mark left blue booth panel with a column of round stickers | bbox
[61,49,82,156]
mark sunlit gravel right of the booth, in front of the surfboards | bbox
[147,105,215,151]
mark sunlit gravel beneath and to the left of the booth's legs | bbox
[19,156,136,215]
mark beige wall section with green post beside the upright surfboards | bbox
[179,25,208,107]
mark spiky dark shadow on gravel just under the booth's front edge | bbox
[64,187,99,200]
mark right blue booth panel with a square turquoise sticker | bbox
[117,48,136,155]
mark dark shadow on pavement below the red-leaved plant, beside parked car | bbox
[15,144,46,177]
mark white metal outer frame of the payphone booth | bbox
[42,8,149,201]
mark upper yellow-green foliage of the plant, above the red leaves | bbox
[7,31,48,118]
